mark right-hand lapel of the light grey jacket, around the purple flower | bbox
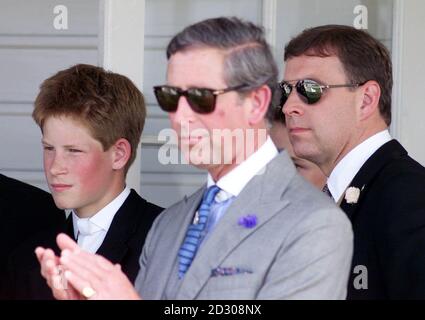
[177,152,295,299]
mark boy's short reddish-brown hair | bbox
[32,64,146,173]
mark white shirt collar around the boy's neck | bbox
[71,186,130,238]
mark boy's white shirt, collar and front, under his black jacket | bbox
[72,187,130,253]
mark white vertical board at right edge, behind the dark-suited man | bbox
[391,0,425,165]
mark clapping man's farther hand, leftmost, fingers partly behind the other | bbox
[35,247,80,300]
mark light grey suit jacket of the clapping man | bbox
[135,151,353,299]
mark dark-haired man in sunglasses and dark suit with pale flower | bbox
[280,25,425,299]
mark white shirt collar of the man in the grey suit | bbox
[207,137,278,197]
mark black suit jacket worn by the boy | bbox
[9,190,162,299]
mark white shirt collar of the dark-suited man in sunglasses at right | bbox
[327,130,392,202]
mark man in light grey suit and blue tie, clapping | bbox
[37,18,353,299]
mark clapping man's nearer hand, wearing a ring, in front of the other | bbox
[57,234,140,300]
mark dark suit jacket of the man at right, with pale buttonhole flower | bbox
[341,140,425,299]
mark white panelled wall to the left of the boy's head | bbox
[0,0,99,190]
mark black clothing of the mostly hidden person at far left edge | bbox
[0,174,65,299]
